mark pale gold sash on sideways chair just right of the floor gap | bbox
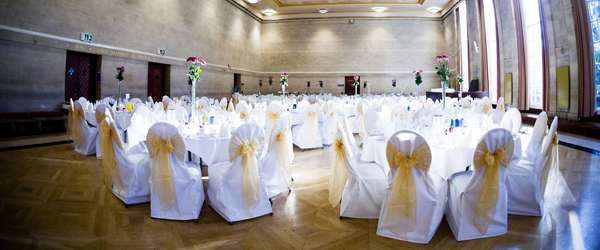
[327,135,352,207]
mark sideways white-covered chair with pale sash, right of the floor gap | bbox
[328,123,387,219]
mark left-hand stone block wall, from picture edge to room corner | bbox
[0,0,261,112]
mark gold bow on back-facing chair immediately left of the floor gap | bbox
[229,133,261,216]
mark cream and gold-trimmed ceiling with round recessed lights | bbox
[229,0,461,21]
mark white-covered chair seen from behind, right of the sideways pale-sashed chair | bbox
[377,130,448,244]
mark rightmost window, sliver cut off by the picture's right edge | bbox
[587,0,600,111]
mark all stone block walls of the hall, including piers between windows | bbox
[0,0,579,118]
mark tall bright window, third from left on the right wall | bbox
[521,0,544,109]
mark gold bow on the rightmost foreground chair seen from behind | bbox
[473,138,514,234]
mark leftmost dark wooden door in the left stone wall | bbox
[65,51,96,101]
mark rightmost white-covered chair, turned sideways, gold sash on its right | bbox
[506,117,558,216]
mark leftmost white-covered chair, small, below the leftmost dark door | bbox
[73,101,98,155]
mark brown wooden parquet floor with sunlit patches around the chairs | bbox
[0,136,600,249]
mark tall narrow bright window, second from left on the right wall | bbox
[483,0,498,103]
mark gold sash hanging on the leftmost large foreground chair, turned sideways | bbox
[96,118,123,193]
